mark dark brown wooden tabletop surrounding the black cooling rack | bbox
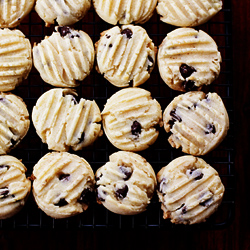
[0,0,250,250]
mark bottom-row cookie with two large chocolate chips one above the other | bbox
[96,151,156,215]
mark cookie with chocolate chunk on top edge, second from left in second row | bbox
[33,26,95,87]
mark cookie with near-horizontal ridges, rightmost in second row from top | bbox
[158,28,222,91]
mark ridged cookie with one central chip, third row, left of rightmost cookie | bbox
[102,88,162,151]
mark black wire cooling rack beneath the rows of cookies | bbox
[0,0,235,230]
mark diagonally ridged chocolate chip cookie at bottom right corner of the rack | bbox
[157,156,225,224]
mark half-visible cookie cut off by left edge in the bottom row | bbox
[0,155,31,219]
